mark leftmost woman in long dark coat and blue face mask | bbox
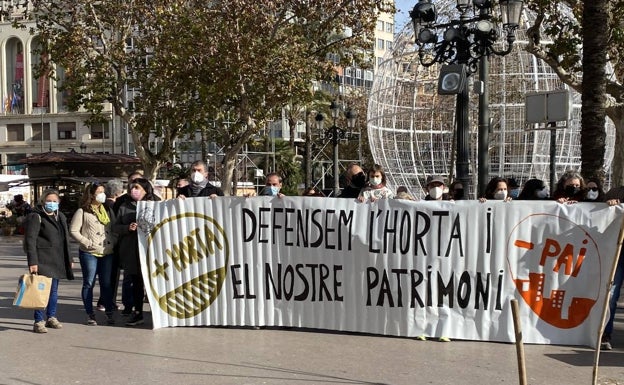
[24,190,74,333]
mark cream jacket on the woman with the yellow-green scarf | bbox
[69,208,117,256]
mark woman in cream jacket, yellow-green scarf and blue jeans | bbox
[69,183,117,325]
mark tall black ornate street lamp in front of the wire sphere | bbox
[410,0,523,195]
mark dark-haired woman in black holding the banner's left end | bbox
[113,178,160,326]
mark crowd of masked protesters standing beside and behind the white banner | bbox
[17,161,624,350]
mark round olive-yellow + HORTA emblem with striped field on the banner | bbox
[147,213,230,318]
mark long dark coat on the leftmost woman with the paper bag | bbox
[24,207,74,279]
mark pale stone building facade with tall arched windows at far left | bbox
[0,19,124,174]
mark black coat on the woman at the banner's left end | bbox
[113,201,141,274]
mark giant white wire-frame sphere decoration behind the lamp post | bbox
[368,5,615,198]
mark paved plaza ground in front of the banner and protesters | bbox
[0,237,624,385]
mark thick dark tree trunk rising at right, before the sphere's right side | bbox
[581,0,617,181]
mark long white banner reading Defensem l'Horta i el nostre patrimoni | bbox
[137,197,623,346]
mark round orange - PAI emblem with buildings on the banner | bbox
[506,214,602,329]
